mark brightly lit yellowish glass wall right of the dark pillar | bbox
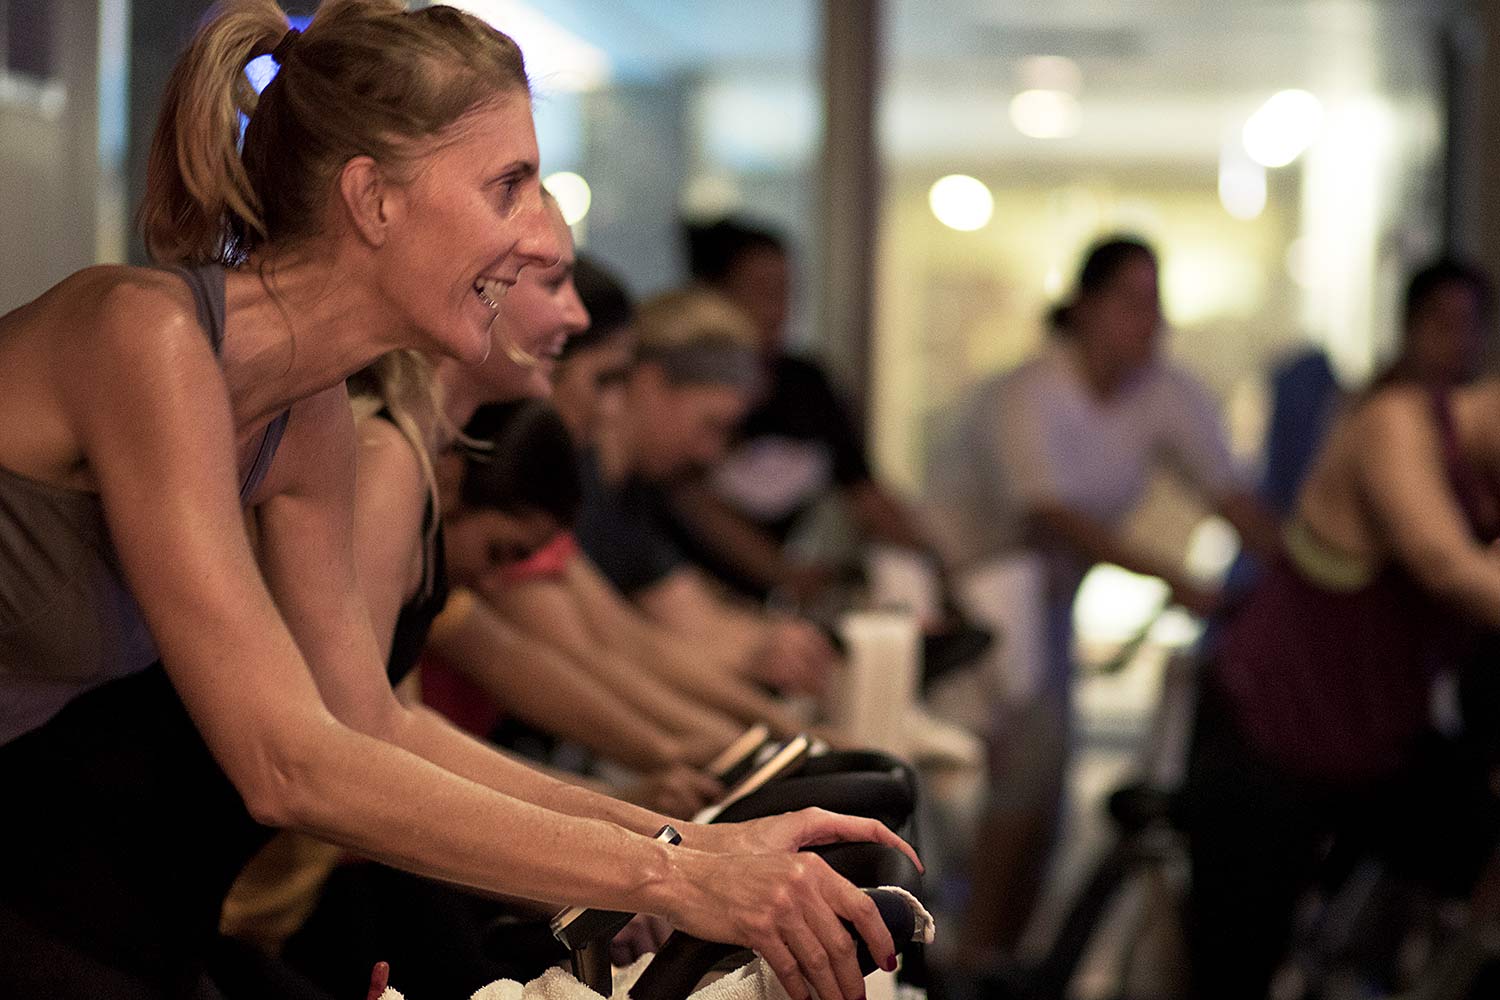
[873,0,1443,489]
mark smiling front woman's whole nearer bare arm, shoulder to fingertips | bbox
[67,279,912,997]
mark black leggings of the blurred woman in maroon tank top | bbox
[1184,676,1494,1000]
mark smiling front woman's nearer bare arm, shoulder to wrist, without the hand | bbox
[69,286,668,903]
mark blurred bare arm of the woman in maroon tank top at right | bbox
[1353,388,1500,627]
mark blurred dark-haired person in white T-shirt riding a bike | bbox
[929,237,1277,972]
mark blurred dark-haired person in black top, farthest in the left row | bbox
[672,219,944,603]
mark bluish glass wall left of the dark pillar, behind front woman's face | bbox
[447,0,822,336]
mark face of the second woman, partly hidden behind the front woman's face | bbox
[471,199,588,402]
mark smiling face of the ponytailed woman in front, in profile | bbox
[378,93,563,364]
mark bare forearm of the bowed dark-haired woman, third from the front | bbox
[428,589,702,771]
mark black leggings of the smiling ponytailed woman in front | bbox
[0,664,270,1000]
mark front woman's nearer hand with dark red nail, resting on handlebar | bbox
[668,845,896,1000]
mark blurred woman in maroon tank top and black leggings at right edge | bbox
[1184,364,1500,1000]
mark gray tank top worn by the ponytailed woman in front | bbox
[0,265,288,745]
